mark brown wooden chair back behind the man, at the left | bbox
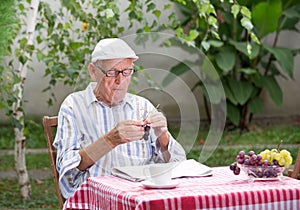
[43,116,65,209]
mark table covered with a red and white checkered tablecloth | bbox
[64,167,300,210]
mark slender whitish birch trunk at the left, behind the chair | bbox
[12,0,39,200]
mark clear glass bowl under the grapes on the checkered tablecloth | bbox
[239,165,285,182]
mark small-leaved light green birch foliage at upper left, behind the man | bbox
[0,0,172,113]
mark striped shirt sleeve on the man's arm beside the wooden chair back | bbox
[53,97,89,198]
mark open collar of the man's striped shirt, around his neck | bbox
[85,82,134,109]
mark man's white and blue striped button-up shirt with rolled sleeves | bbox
[53,83,186,198]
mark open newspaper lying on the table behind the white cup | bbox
[112,159,212,181]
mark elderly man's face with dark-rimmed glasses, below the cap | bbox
[94,59,133,106]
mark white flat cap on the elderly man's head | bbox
[92,38,139,62]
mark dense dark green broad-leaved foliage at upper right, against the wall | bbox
[164,0,300,130]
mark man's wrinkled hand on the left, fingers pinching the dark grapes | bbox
[105,120,144,147]
